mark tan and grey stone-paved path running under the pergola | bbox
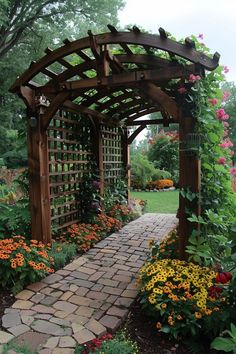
[0,214,177,354]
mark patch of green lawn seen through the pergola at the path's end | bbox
[131,191,179,214]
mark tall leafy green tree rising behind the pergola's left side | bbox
[0,0,124,167]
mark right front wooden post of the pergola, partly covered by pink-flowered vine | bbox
[178,117,201,259]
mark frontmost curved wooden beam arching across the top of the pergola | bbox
[11,32,219,92]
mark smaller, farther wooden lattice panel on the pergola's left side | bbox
[101,126,124,185]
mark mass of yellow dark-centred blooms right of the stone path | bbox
[140,259,219,329]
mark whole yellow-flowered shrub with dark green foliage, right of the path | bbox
[140,259,223,338]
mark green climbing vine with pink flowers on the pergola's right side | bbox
[183,38,236,232]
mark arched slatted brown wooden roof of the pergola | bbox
[11,25,219,128]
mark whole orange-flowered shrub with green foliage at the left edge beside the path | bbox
[0,236,54,293]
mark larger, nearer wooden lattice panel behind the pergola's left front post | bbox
[47,110,94,229]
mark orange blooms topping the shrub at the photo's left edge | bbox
[0,236,54,273]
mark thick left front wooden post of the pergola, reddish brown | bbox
[28,100,51,244]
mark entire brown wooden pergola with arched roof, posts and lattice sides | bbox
[11,25,219,254]
